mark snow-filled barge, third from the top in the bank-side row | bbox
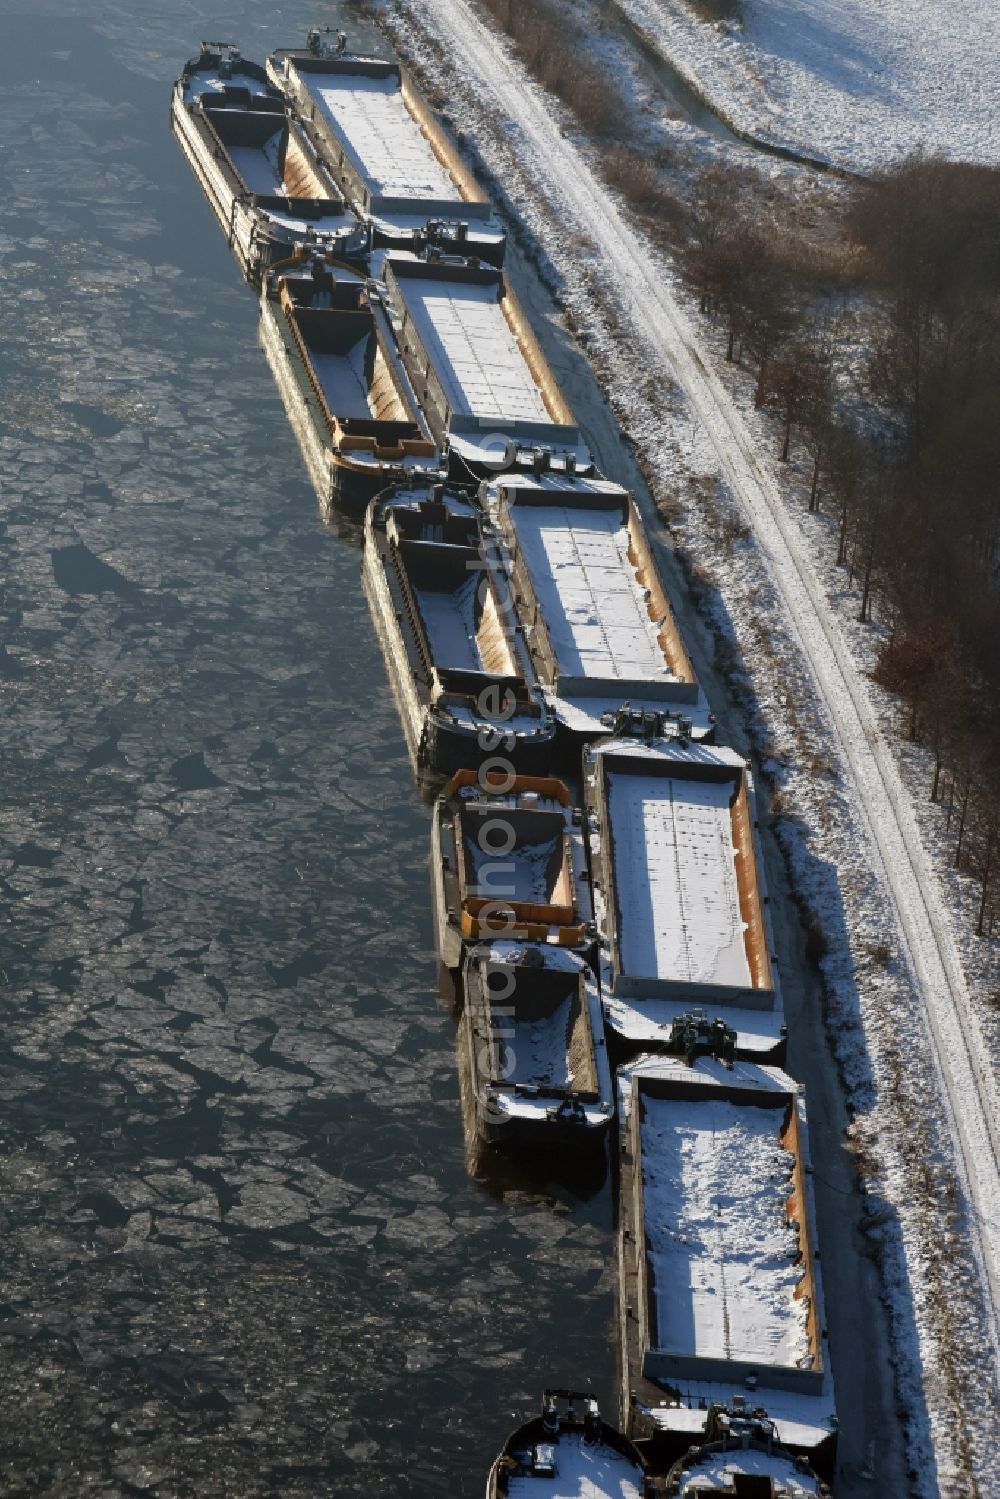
[481,474,715,745]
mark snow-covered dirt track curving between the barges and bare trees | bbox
[404,0,1000,1415]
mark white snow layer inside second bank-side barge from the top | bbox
[403,279,552,423]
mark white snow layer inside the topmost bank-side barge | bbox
[303,73,462,202]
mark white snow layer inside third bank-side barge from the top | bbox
[511,505,672,681]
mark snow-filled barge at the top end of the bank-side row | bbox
[267,43,507,265]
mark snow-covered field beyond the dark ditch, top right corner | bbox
[613,0,1000,172]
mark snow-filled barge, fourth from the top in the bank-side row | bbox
[583,738,786,1061]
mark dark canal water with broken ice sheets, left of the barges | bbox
[0,0,613,1499]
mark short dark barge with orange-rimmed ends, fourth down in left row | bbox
[430,767,594,974]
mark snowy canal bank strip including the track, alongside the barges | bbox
[374,0,1000,1495]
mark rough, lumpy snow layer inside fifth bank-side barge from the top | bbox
[642,1096,810,1367]
